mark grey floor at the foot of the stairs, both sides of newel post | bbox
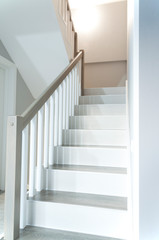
[0,192,120,240]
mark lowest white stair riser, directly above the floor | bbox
[27,200,128,239]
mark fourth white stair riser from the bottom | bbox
[62,129,127,146]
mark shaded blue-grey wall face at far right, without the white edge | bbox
[139,0,159,240]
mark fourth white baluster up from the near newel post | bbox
[44,101,49,168]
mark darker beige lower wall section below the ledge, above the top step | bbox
[84,61,127,88]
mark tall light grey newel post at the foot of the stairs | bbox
[4,116,23,240]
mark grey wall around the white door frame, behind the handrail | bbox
[0,41,34,115]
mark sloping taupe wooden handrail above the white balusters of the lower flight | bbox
[21,51,83,129]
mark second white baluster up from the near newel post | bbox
[29,115,37,197]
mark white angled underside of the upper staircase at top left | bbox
[0,0,69,98]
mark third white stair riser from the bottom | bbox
[55,146,127,168]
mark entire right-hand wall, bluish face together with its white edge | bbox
[128,0,159,240]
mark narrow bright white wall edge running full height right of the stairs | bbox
[127,0,139,240]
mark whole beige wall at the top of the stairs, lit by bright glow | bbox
[72,1,127,87]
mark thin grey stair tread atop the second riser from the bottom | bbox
[49,164,127,174]
